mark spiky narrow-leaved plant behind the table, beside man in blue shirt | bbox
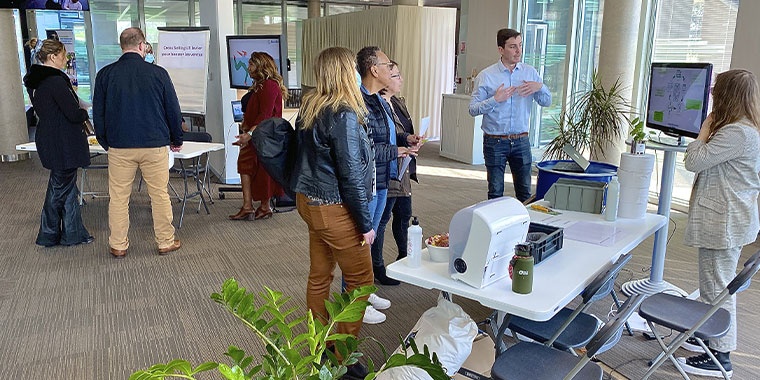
[544,72,632,159]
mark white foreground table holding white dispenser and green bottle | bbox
[387,210,667,356]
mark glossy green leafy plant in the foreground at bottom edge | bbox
[129,278,449,380]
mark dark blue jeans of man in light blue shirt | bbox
[483,136,533,202]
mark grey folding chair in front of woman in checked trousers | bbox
[639,251,760,380]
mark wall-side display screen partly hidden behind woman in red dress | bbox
[227,35,283,89]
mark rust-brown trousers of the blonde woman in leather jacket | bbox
[296,194,375,336]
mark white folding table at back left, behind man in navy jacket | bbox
[16,141,224,227]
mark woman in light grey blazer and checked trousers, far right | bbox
[678,69,760,377]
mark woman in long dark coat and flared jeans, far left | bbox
[24,40,93,247]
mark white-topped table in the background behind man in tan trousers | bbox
[16,141,224,228]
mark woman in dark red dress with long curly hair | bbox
[230,52,288,220]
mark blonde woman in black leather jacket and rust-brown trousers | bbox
[291,47,375,379]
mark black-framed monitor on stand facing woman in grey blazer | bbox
[647,63,712,137]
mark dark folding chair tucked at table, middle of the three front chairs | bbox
[507,253,632,354]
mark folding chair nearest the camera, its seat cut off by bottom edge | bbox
[491,294,644,380]
